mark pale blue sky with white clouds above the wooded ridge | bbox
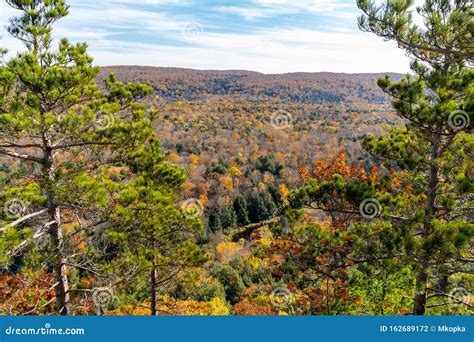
[0,0,409,74]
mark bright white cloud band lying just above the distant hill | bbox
[85,26,408,73]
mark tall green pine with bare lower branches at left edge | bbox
[0,0,153,315]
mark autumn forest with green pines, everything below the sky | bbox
[0,0,474,316]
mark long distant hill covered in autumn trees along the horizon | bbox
[100,66,402,104]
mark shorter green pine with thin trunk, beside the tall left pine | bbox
[110,140,206,315]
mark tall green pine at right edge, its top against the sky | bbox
[358,0,474,315]
